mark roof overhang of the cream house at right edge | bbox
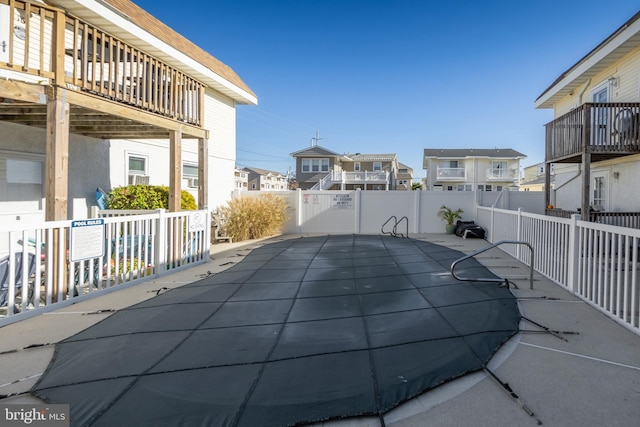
[535,12,640,108]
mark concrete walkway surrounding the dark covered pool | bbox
[0,234,640,427]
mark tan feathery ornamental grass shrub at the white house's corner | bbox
[219,194,287,241]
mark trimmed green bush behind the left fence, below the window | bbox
[107,185,198,211]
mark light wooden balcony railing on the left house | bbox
[0,0,205,126]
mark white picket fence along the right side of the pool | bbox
[476,207,640,333]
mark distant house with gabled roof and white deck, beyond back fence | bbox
[291,145,406,191]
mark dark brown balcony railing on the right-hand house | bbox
[546,103,640,162]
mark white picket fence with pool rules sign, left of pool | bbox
[0,210,210,326]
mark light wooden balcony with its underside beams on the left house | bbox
[0,0,205,138]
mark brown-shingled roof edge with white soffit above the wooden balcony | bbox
[47,0,257,104]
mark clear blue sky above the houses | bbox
[134,0,640,178]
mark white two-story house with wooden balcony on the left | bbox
[0,0,257,222]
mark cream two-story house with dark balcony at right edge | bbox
[535,13,640,218]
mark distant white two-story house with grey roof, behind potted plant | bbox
[423,148,526,191]
